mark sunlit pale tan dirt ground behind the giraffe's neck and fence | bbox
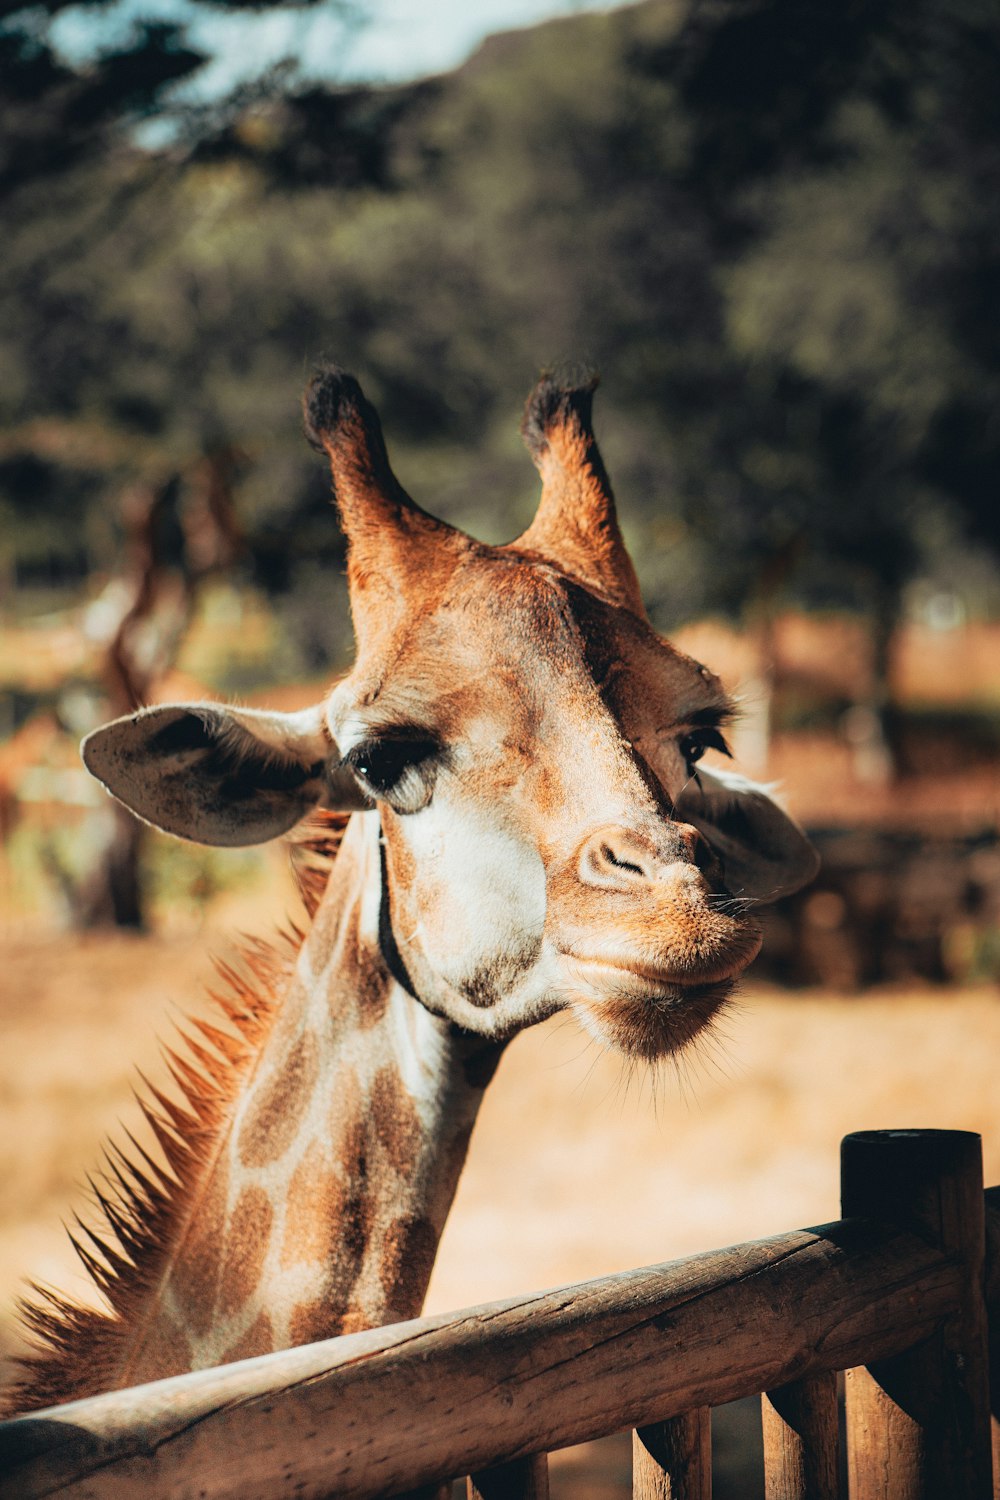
[0,924,1000,1500]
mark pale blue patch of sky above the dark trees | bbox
[54,0,624,96]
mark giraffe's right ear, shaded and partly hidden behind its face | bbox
[676,767,820,902]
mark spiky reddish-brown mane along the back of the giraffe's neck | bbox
[1,812,348,1415]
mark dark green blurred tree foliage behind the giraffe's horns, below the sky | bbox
[0,0,1000,642]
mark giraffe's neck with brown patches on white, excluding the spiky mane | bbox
[118,813,501,1385]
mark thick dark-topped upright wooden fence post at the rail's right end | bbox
[841,1131,993,1500]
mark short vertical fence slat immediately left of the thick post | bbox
[760,1370,840,1500]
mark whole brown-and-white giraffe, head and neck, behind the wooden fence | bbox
[15,366,816,1409]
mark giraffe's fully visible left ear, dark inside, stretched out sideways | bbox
[81,704,369,846]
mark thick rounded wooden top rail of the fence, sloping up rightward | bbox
[0,1221,964,1500]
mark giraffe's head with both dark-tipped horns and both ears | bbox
[84,369,816,1058]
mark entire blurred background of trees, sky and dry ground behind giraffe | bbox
[0,0,1000,1494]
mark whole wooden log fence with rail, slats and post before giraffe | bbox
[0,1131,1000,1500]
